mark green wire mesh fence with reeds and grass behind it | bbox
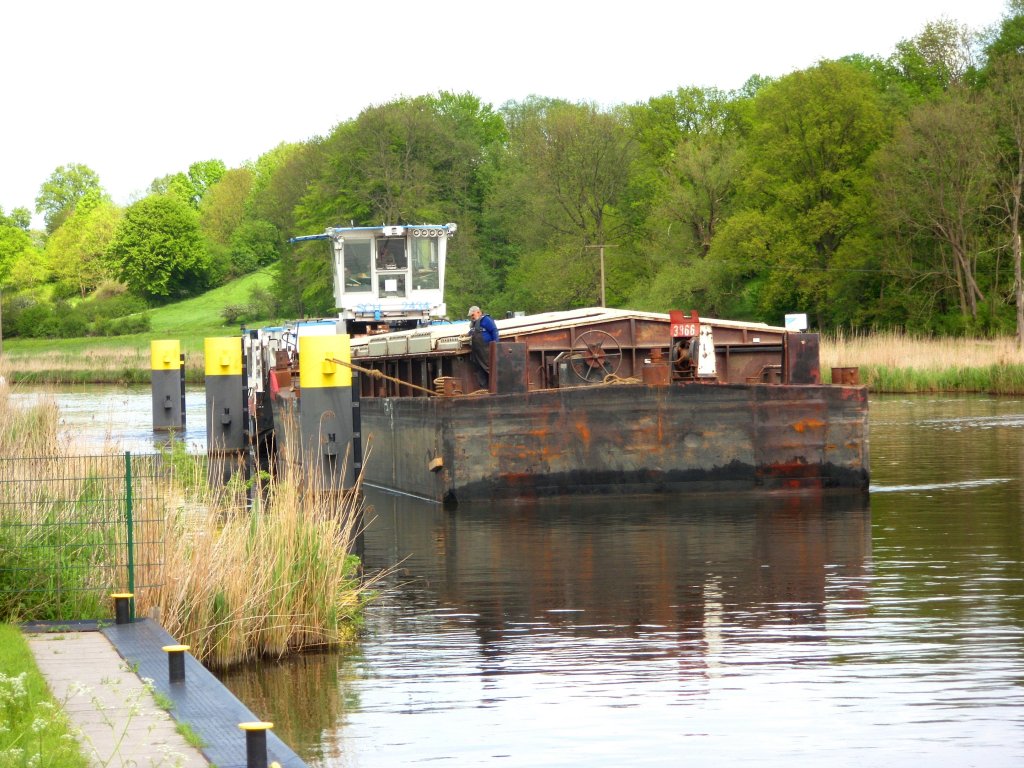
[0,453,166,622]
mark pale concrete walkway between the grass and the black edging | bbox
[26,632,210,768]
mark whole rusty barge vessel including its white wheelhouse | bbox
[243,223,868,504]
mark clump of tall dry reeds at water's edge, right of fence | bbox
[154,450,372,666]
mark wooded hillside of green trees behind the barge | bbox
[0,0,1024,337]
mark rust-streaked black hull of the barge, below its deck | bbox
[360,384,868,504]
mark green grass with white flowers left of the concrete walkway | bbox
[0,624,88,768]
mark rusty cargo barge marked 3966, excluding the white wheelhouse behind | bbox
[351,307,869,504]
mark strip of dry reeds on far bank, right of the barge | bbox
[821,332,1024,394]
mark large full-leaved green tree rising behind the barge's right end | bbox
[740,61,891,327]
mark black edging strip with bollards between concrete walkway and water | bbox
[102,620,305,768]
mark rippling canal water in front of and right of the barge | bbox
[14,396,1024,768]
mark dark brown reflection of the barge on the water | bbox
[367,495,869,653]
